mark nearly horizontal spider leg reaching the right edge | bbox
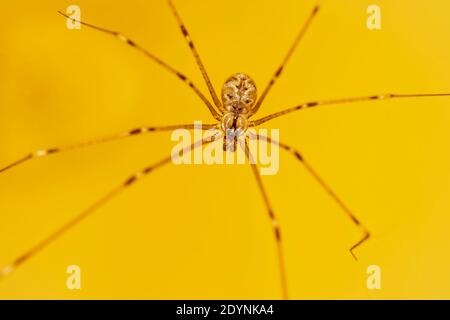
[249,93,450,127]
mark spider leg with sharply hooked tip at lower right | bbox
[250,135,370,260]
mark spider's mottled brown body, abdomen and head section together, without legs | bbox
[222,73,257,151]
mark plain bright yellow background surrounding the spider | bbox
[0,0,450,299]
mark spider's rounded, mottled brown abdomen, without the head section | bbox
[222,73,257,115]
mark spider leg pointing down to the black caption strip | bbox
[241,140,288,300]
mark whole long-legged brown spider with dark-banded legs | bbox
[0,0,450,299]
